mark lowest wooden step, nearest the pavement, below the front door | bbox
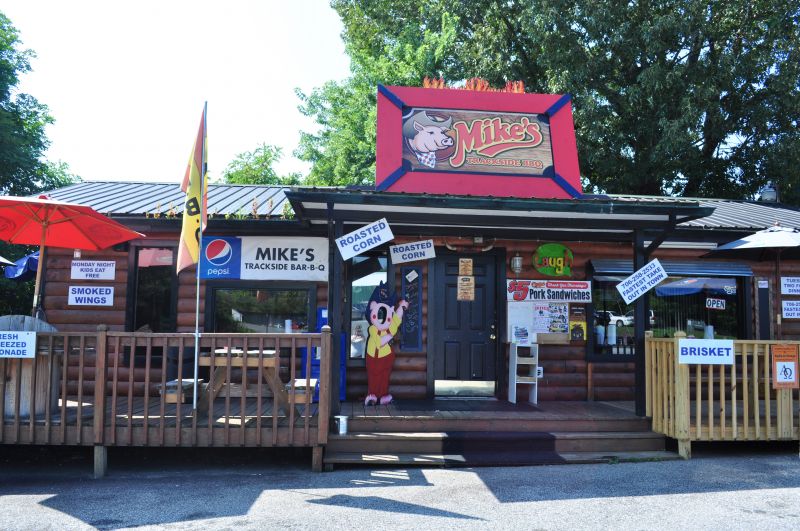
[324,450,680,468]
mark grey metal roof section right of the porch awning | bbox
[608,194,800,232]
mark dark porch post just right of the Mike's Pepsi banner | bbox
[328,202,344,415]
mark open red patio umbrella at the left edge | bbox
[0,195,144,316]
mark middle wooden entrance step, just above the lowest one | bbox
[327,431,664,454]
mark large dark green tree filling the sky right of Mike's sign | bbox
[301,0,800,201]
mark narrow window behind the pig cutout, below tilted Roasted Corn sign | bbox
[350,253,389,359]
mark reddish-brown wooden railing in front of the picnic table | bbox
[0,327,331,468]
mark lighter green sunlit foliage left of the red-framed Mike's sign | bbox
[295,8,456,186]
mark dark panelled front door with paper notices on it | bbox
[431,255,497,394]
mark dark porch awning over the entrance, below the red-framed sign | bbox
[286,189,713,241]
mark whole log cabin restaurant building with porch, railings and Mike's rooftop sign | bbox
[0,87,800,475]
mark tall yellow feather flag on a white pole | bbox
[178,107,208,273]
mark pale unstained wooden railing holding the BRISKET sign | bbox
[645,332,800,458]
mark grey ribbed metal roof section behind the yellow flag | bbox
[40,181,287,218]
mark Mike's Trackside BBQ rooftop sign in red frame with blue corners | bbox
[376,86,581,198]
